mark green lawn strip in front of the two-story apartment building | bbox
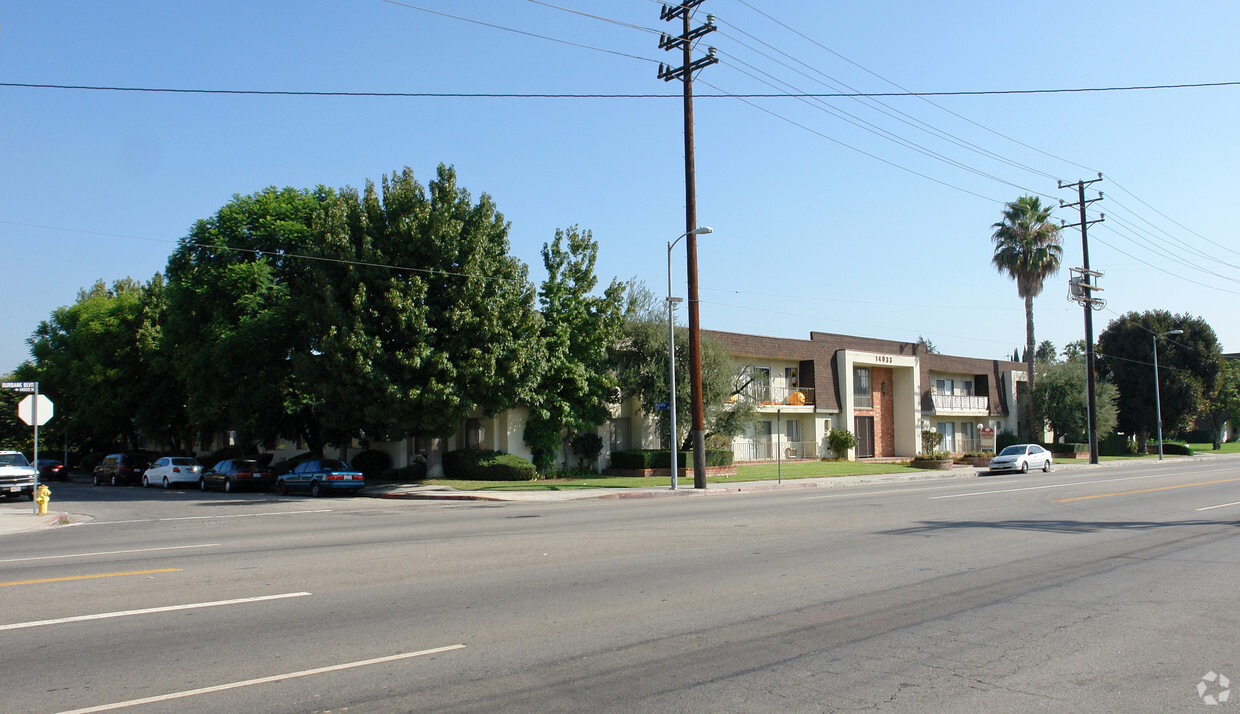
[379,461,924,491]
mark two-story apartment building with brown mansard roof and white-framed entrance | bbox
[703,331,1027,461]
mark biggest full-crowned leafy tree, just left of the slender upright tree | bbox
[314,165,543,476]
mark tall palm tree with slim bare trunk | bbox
[991,196,1064,436]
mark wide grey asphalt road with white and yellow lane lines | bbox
[0,459,1240,713]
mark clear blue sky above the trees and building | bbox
[0,0,1240,372]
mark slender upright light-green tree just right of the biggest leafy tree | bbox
[523,226,624,471]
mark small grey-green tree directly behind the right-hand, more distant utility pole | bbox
[1034,357,1117,443]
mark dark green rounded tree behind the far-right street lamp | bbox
[1097,310,1221,443]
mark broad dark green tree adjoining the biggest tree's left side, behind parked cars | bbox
[160,187,356,454]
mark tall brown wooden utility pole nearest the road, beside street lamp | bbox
[658,0,719,488]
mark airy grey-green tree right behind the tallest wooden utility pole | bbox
[613,281,755,447]
